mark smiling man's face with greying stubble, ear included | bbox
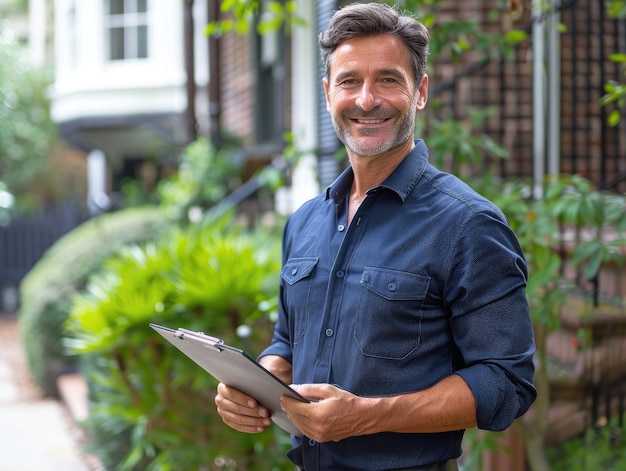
[324,34,428,156]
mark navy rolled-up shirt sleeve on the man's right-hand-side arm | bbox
[446,211,537,430]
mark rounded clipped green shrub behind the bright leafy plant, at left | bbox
[19,207,169,396]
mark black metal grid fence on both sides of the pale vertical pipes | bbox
[430,0,626,193]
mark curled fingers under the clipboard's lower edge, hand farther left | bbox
[215,383,272,433]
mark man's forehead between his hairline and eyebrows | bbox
[330,34,412,79]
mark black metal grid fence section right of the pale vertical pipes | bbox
[561,0,626,193]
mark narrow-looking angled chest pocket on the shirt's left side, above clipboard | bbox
[280,257,319,345]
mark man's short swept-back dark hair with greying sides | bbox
[319,3,430,87]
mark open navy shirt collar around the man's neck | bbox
[326,139,428,204]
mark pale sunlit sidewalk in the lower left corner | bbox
[0,313,98,471]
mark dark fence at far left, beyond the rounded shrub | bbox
[0,204,81,312]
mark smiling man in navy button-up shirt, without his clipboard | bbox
[216,3,536,471]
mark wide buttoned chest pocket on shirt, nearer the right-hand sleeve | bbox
[354,267,430,360]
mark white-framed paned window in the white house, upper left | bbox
[105,0,148,61]
